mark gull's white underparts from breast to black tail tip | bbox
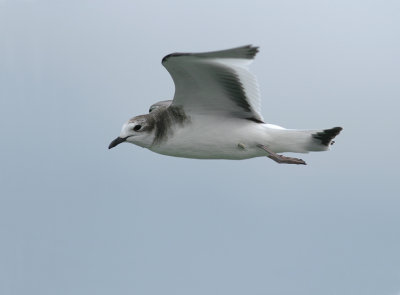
[150,115,324,159]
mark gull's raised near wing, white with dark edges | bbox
[162,45,263,122]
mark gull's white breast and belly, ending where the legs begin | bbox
[150,116,268,159]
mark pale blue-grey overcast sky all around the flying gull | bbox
[0,0,400,295]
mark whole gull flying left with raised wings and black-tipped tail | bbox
[108,45,342,165]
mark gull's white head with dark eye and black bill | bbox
[108,115,154,149]
